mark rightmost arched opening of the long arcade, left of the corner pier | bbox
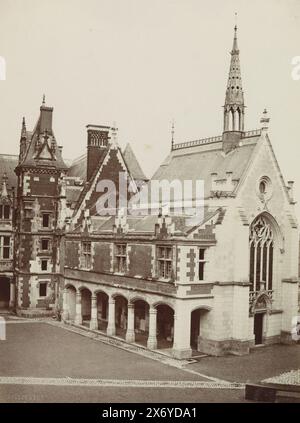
[156,304,174,349]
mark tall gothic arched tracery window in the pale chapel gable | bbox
[249,216,274,291]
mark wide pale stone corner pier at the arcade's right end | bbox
[173,303,192,358]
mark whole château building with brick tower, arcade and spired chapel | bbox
[0,27,299,358]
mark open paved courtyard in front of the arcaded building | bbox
[0,317,300,403]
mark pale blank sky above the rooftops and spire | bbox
[0,0,300,211]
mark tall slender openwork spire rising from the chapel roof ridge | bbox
[224,25,245,132]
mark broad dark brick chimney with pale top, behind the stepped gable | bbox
[87,125,110,182]
